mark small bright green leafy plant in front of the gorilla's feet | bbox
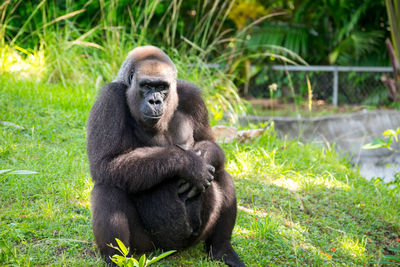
[108,238,176,267]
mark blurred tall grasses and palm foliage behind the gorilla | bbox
[0,0,389,101]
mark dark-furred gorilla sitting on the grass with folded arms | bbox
[87,46,244,266]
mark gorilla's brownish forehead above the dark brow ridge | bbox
[136,60,176,78]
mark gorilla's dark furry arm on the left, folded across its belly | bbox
[87,83,211,193]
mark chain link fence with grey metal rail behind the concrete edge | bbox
[249,65,393,106]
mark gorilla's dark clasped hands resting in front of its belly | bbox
[178,151,215,198]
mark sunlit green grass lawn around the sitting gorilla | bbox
[0,76,400,266]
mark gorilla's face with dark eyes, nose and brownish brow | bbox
[128,59,177,130]
